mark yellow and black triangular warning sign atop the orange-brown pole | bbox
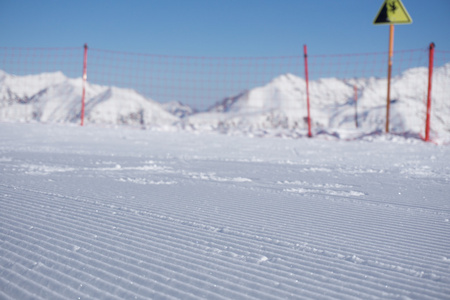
[373,0,412,24]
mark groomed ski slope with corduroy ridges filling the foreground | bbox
[0,123,450,299]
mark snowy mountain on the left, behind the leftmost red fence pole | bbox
[0,72,178,126]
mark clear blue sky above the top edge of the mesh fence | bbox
[0,0,450,57]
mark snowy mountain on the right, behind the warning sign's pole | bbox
[183,64,450,141]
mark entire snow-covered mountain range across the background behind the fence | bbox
[0,63,450,141]
